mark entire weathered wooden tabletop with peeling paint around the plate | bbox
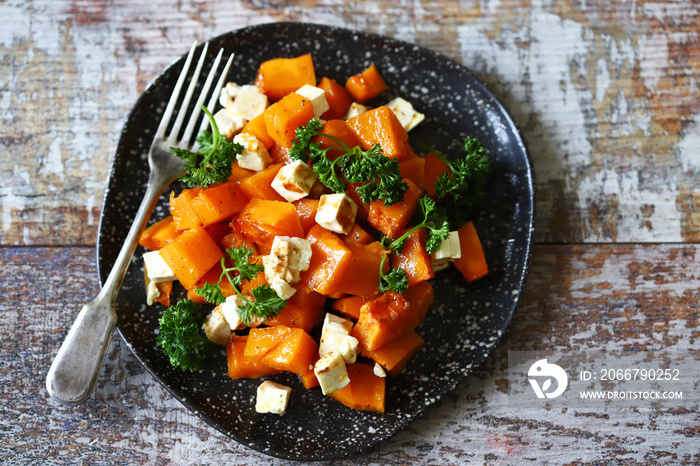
[0,0,700,464]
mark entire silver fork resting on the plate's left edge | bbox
[46,41,233,405]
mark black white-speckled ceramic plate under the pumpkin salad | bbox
[98,23,533,460]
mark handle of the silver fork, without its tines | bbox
[46,171,172,405]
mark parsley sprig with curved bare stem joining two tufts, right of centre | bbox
[379,196,450,293]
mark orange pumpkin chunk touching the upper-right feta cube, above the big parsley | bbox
[348,106,413,158]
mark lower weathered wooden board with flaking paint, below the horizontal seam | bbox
[0,245,700,465]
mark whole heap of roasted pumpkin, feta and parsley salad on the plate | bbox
[140,55,489,414]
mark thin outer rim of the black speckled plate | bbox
[96,22,535,461]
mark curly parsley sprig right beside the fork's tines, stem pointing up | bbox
[170,106,243,187]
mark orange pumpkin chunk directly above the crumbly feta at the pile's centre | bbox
[234,198,304,253]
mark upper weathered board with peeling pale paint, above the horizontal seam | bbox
[0,0,700,245]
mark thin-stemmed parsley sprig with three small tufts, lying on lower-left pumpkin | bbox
[197,246,287,325]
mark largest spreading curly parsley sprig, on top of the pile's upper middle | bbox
[289,118,408,206]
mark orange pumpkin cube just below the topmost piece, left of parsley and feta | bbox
[263,91,314,147]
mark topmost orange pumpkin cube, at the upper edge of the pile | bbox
[255,54,316,101]
